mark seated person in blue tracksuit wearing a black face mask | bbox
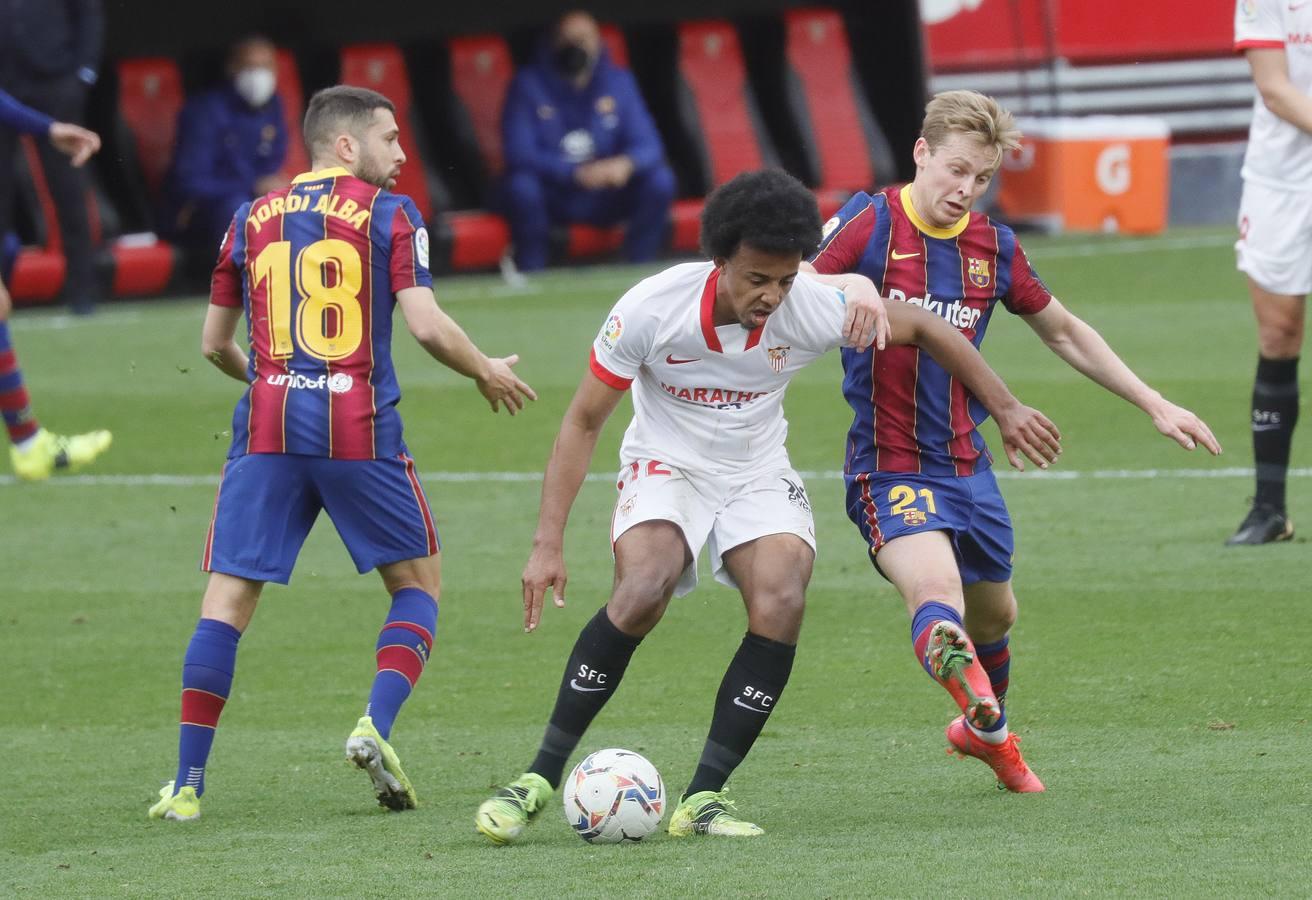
[500,12,674,272]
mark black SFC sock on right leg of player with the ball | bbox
[685,631,798,796]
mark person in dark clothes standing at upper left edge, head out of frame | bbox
[0,0,105,315]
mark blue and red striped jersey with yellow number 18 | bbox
[210,168,433,459]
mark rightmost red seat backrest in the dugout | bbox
[783,9,893,203]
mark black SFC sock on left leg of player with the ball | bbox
[529,606,643,787]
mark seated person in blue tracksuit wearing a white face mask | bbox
[163,37,287,262]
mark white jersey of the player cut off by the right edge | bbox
[1235,0,1312,190]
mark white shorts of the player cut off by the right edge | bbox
[1235,181,1312,297]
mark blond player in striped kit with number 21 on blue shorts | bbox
[812,91,1220,792]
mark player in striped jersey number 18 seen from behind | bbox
[150,85,537,820]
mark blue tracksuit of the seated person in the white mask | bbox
[164,85,287,252]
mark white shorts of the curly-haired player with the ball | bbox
[610,459,816,597]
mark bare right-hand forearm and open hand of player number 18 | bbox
[396,287,538,416]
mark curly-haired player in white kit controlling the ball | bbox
[475,171,1060,844]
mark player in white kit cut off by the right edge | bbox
[1225,0,1312,544]
